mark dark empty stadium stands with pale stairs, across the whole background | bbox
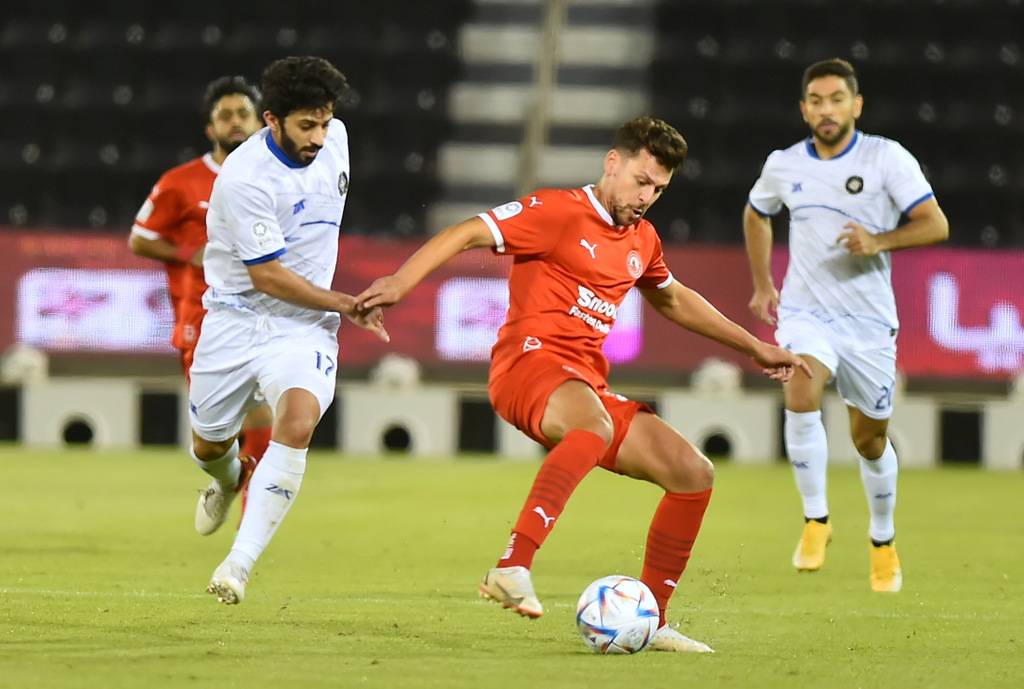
[0,0,1024,248]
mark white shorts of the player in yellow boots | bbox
[775,316,896,419]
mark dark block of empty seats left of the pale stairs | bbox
[0,0,472,234]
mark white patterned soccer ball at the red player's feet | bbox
[577,574,658,653]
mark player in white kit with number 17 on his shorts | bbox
[188,56,388,604]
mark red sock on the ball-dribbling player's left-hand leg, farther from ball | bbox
[498,430,608,569]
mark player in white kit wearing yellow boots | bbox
[743,58,949,592]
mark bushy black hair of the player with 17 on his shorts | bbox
[263,55,348,120]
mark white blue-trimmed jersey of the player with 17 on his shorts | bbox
[203,120,349,330]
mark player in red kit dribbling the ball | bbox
[356,117,810,652]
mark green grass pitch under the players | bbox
[0,445,1024,689]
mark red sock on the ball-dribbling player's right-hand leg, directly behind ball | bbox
[640,488,711,627]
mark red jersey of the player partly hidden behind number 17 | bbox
[132,154,220,351]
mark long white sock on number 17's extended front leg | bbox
[227,440,308,569]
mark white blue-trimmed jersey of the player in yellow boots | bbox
[750,131,933,346]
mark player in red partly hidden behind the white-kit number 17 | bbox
[128,77,273,509]
